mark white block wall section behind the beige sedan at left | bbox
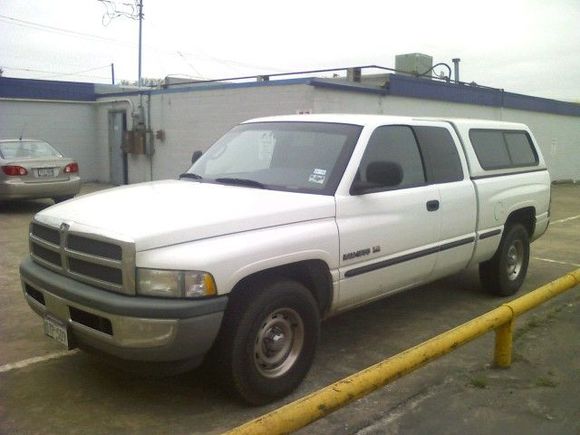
[0,99,100,181]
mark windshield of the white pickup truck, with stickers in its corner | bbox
[186,122,362,195]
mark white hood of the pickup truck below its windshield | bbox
[35,180,335,251]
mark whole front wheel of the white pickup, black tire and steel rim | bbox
[216,280,320,405]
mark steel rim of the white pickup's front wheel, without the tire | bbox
[254,308,304,378]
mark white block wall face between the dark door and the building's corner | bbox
[129,85,313,183]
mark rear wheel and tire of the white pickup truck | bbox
[479,224,530,296]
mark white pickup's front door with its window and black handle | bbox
[336,125,441,309]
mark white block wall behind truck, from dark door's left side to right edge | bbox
[90,84,580,183]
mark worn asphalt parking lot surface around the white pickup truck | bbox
[0,184,580,435]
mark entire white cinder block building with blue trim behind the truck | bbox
[0,74,580,184]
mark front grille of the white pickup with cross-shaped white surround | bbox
[30,222,135,294]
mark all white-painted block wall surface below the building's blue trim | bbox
[0,84,580,183]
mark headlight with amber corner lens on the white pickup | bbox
[137,269,217,298]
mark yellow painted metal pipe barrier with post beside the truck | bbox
[228,269,580,435]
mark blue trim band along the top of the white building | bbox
[0,65,580,117]
